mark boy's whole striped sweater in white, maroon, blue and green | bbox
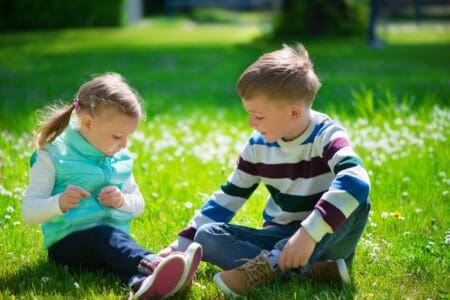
[178,111,370,242]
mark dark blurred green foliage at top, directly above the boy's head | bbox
[274,0,368,37]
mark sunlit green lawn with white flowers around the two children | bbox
[0,18,450,299]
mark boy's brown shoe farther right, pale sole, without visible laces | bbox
[303,259,351,284]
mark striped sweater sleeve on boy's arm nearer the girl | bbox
[170,144,260,251]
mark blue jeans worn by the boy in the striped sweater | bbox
[194,202,370,273]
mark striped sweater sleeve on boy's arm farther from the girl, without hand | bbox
[302,122,370,242]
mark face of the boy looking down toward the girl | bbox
[242,94,302,143]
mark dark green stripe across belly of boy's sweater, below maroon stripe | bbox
[267,185,325,212]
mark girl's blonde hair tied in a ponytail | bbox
[35,73,144,149]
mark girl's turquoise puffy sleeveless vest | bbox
[31,123,133,248]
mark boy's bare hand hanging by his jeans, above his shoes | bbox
[279,228,316,271]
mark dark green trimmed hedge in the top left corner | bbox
[0,0,125,30]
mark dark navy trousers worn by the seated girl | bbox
[48,225,156,285]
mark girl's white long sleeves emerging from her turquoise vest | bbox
[22,150,144,224]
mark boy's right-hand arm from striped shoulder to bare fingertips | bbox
[279,123,370,270]
